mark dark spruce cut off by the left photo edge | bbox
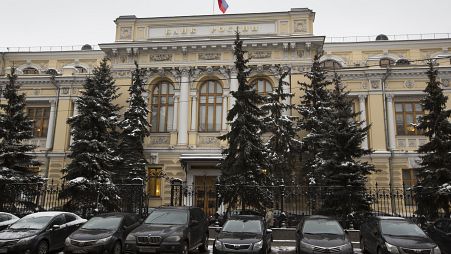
[0,68,43,208]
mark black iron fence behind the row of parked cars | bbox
[0,182,424,229]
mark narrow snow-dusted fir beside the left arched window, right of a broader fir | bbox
[117,62,151,182]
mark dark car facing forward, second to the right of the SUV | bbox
[296,215,354,254]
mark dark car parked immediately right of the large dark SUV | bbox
[213,215,272,254]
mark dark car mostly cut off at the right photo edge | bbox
[427,219,451,254]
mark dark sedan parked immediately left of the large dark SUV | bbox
[64,213,140,254]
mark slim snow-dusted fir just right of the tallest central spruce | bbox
[261,70,300,184]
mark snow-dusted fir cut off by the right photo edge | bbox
[415,60,451,219]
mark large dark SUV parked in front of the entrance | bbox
[125,207,208,254]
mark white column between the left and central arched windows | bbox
[177,69,189,145]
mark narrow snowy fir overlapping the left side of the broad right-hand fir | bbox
[297,54,331,187]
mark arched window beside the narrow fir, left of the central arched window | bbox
[152,81,174,132]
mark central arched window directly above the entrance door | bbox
[199,80,222,132]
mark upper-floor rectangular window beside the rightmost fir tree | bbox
[395,102,424,135]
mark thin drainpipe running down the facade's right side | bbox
[381,66,396,214]
